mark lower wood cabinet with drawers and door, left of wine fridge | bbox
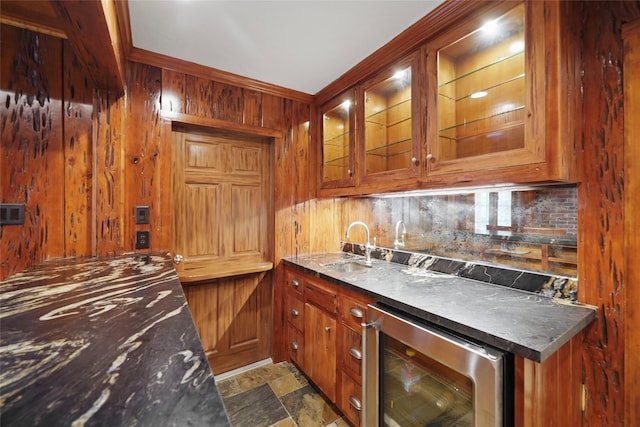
[284,267,374,426]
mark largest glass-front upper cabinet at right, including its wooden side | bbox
[424,2,578,186]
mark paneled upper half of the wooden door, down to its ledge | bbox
[173,129,271,281]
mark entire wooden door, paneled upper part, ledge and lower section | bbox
[172,128,273,374]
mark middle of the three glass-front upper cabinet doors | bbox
[360,55,420,181]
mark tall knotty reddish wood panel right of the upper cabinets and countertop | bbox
[578,2,637,426]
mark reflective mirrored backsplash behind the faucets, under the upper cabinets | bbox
[349,185,577,276]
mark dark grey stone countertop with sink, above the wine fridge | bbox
[283,252,596,362]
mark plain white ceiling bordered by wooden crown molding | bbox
[129,0,443,94]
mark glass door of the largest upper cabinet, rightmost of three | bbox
[427,3,544,176]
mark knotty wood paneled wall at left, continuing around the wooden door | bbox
[0,25,317,278]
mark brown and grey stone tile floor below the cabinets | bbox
[218,362,349,427]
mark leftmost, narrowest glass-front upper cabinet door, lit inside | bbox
[320,91,355,188]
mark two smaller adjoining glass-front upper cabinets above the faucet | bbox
[318,52,421,195]
